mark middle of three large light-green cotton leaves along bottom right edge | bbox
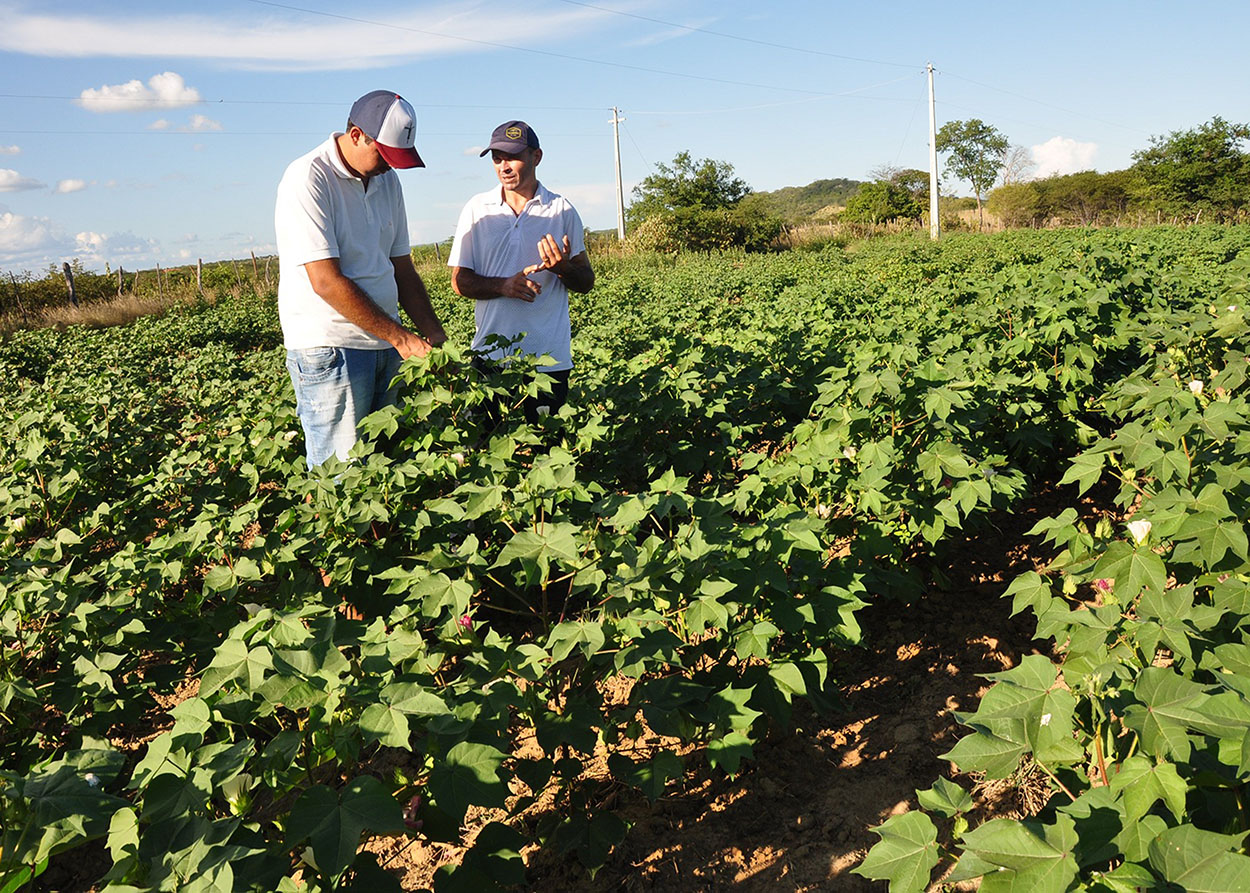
[964,814,1079,893]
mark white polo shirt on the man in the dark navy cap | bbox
[448,183,586,371]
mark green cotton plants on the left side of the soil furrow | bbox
[0,229,1248,890]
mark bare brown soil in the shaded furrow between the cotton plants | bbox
[39,499,1075,893]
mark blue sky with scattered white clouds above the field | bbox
[0,0,1250,274]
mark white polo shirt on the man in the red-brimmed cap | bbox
[274,134,411,350]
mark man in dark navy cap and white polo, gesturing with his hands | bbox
[448,121,595,421]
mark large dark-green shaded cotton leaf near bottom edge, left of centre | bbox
[286,775,404,882]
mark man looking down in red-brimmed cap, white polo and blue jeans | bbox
[274,90,448,468]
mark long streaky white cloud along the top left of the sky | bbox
[0,0,609,70]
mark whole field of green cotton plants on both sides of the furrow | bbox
[0,228,1250,893]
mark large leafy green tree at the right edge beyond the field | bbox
[1133,118,1250,218]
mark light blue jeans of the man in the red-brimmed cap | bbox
[286,348,400,469]
